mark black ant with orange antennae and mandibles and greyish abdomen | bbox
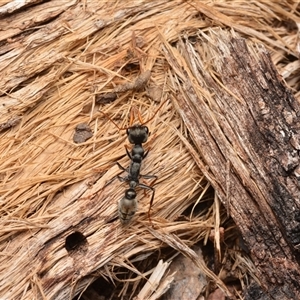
[102,102,165,224]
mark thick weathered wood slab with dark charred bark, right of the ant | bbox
[169,31,300,299]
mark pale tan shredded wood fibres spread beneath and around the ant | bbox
[0,0,300,299]
